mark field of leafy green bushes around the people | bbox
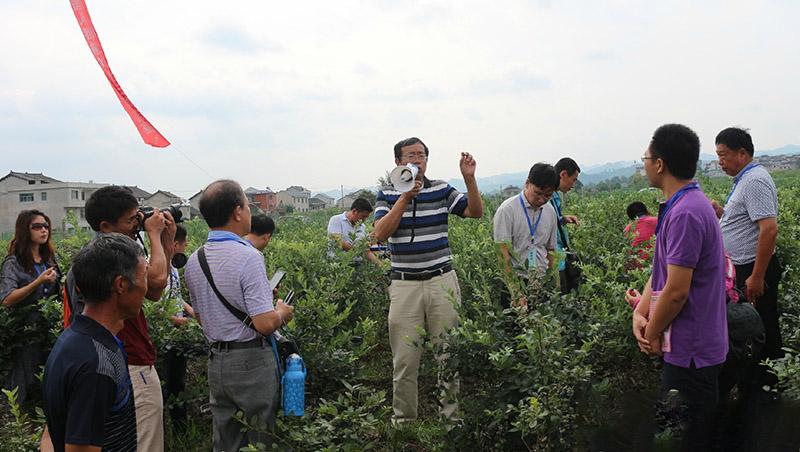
[0,172,800,451]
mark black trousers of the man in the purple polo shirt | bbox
[661,362,722,452]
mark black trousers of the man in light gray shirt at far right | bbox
[735,255,783,386]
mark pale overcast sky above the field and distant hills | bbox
[0,0,800,197]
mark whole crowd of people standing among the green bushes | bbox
[0,124,782,451]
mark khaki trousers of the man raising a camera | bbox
[128,365,164,452]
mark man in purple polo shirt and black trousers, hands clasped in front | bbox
[633,124,728,450]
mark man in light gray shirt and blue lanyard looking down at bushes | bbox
[494,163,559,307]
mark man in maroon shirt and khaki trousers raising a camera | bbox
[65,185,175,451]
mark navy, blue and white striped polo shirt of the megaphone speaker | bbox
[375,178,467,273]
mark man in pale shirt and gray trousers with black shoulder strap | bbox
[184,180,294,451]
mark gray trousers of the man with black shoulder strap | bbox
[208,342,280,452]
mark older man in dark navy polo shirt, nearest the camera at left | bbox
[43,234,147,451]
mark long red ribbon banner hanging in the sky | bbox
[70,0,169,148]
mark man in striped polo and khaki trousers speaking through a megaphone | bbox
[373,137,483,423]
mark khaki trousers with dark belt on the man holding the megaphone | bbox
[389,271,461,422]
